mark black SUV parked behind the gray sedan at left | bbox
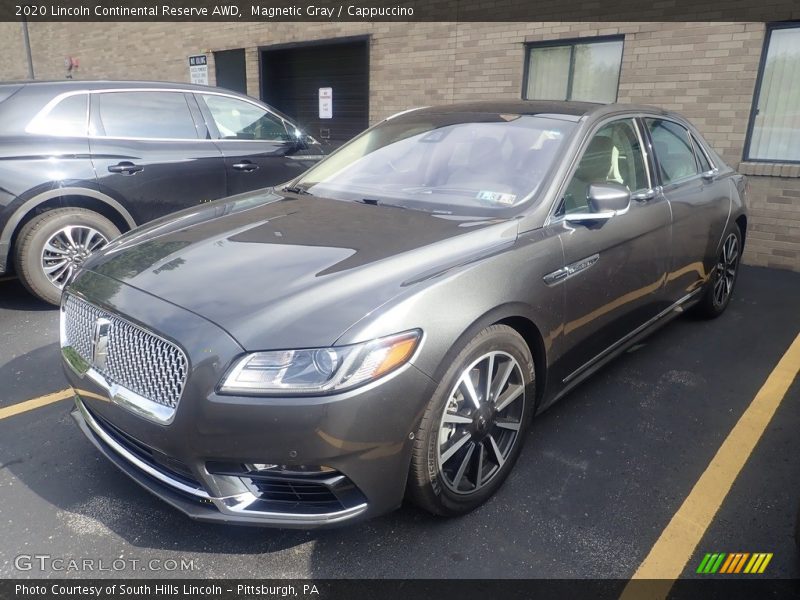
[0,81,323,304]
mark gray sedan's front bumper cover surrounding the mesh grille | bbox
[62,273,435,527]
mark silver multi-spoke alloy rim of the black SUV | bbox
[42,225,108,289]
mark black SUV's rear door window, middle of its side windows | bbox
[95,91,197,140]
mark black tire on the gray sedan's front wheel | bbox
[407,325,535,516]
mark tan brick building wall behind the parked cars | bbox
[0,22,800,271]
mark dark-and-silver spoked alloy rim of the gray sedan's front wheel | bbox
[437,352,526,494]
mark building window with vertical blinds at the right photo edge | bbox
[745,23,800,162]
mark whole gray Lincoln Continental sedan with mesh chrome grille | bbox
[61,101,747,527]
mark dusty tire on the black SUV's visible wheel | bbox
[14,208,120,305]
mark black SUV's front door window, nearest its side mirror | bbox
[200,94,289,141]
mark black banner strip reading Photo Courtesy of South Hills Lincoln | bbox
[0,575,800,600]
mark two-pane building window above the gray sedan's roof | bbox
[525,37,623,102]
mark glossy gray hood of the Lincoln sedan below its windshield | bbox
[86,191,517,350]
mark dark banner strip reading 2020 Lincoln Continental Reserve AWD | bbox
[0,0,800,23]
